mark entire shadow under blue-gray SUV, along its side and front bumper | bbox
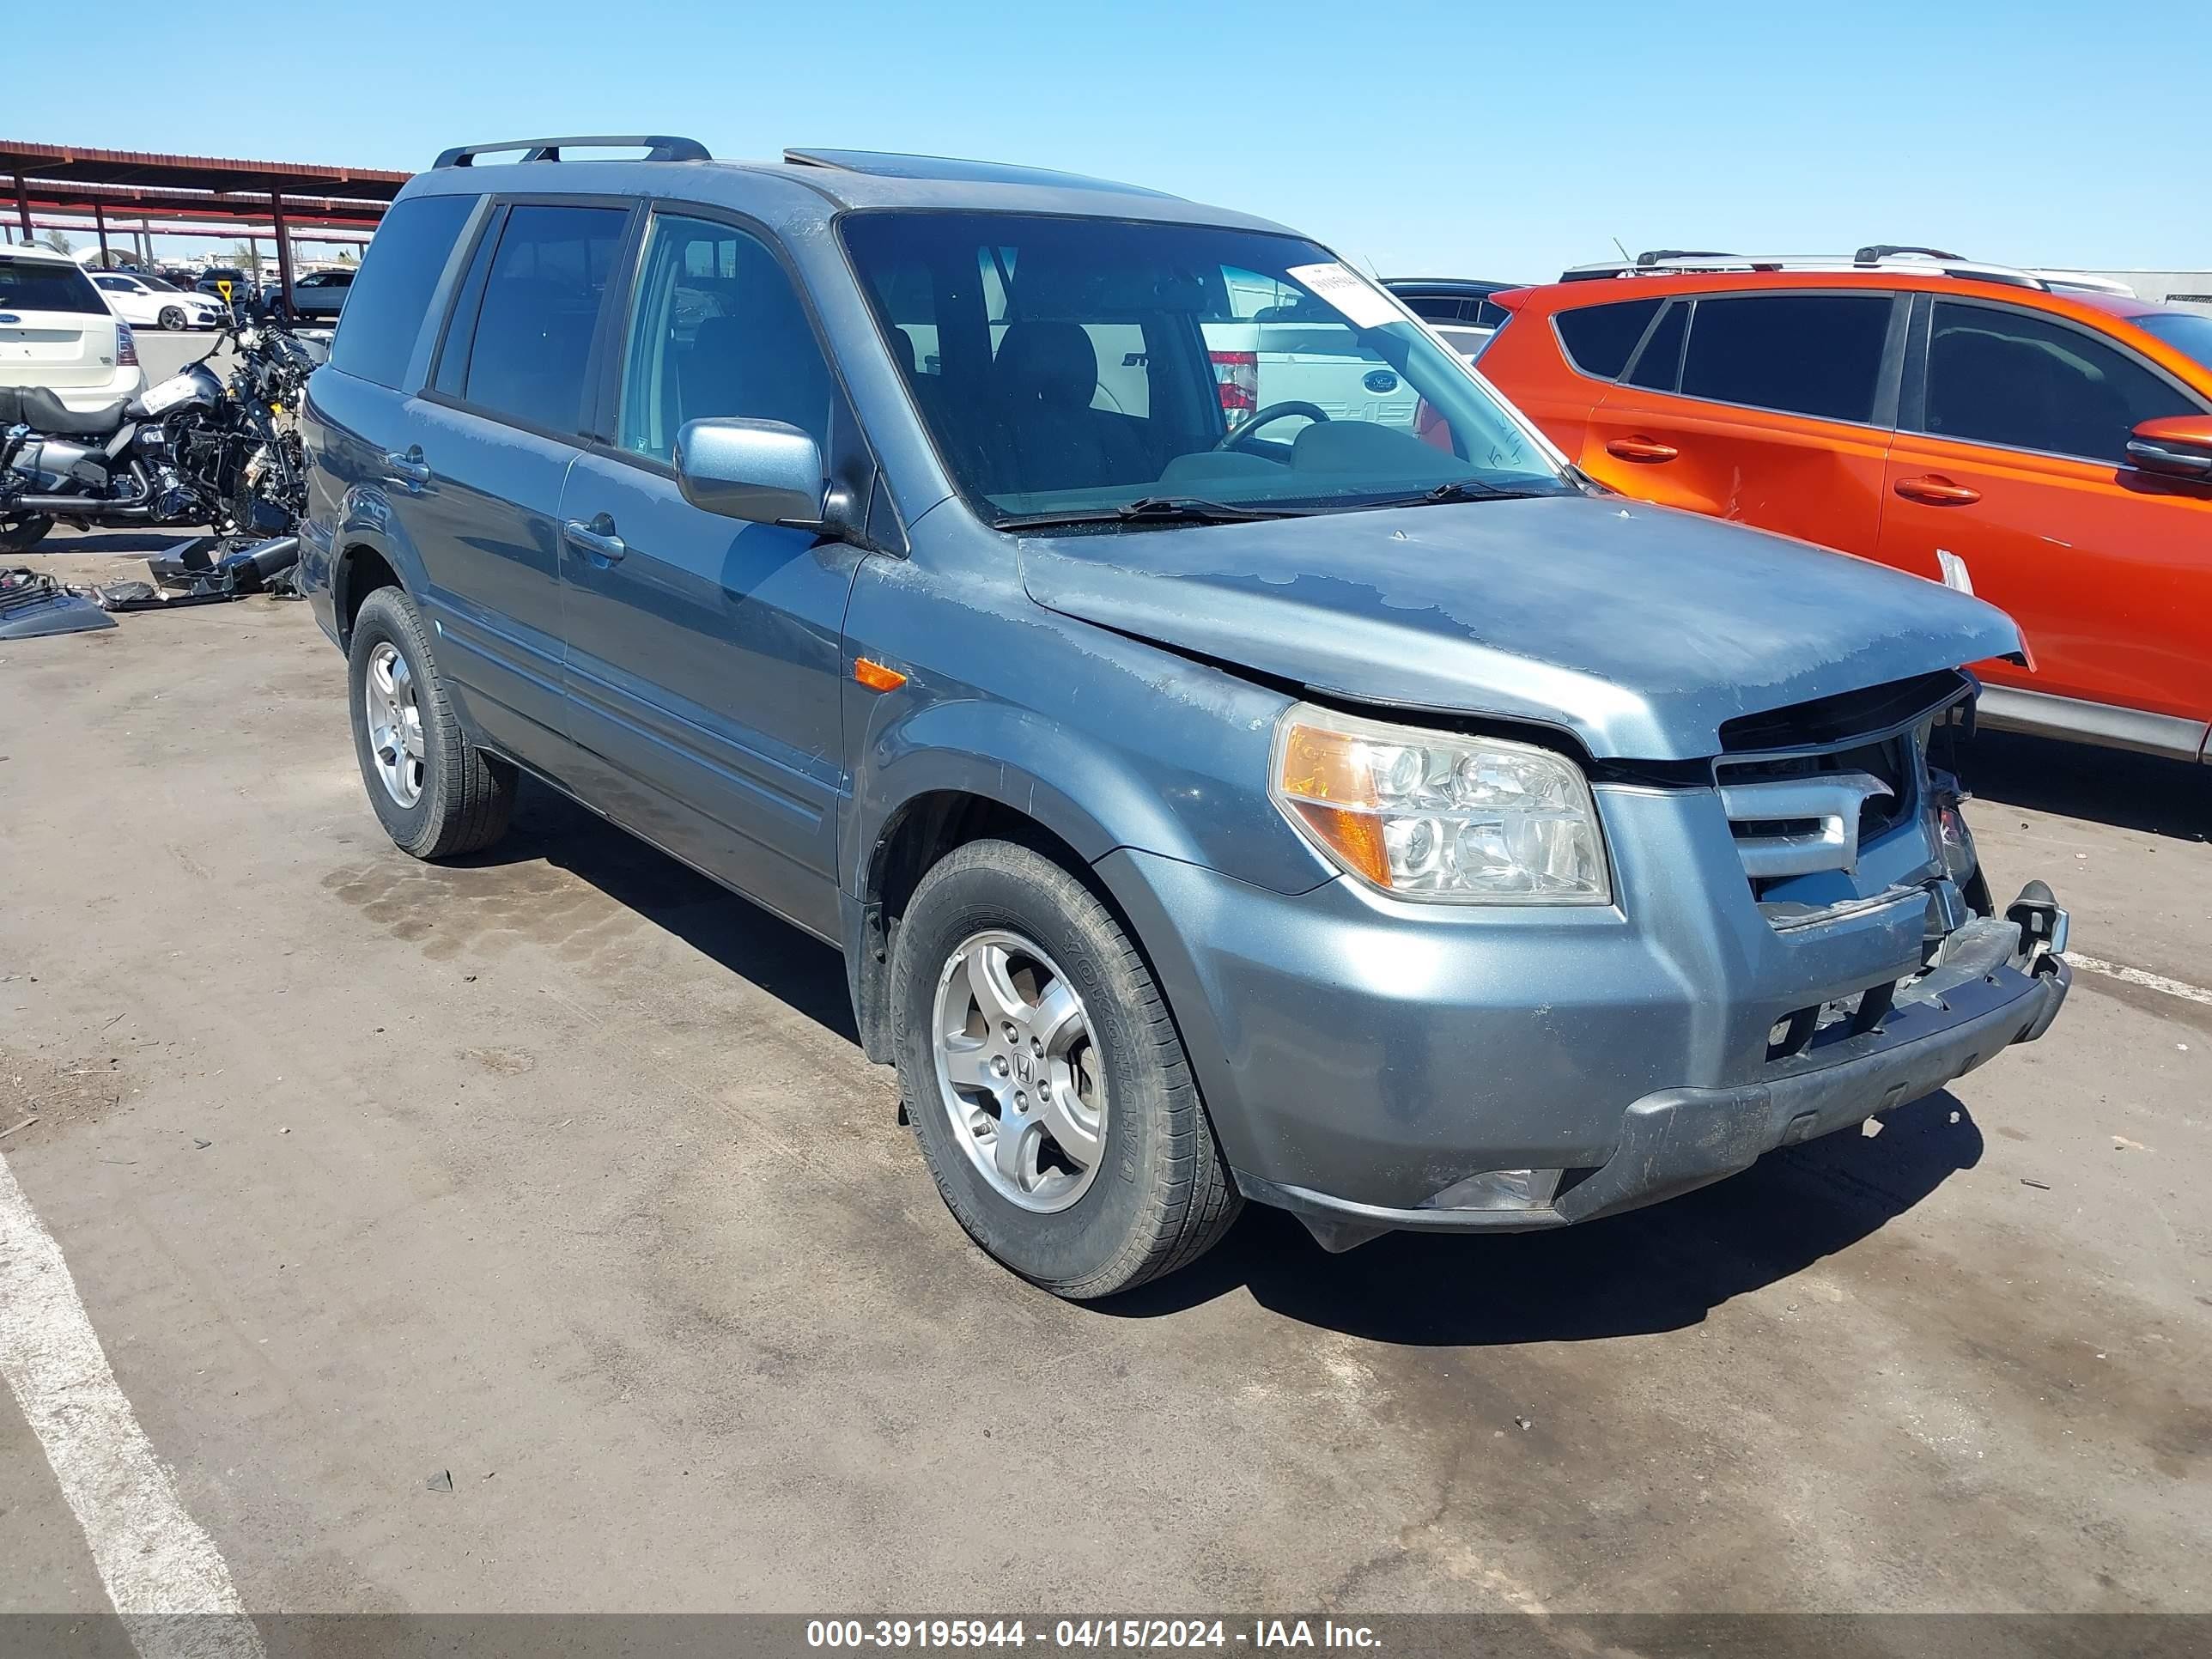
[456,779,1982,1347]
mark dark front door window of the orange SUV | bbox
[1924,301,2199,465]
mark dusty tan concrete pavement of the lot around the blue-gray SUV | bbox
[0,417,2212,1613]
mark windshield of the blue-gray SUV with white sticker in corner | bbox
[842,212,1571,526]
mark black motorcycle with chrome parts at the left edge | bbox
[0,298,319,553]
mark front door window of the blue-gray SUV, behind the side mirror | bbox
[617,215,832,460]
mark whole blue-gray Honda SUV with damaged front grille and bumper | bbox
[301,139,2069,1297]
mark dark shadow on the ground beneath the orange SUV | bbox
[1942,732,2212,841]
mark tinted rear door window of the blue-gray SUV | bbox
[444,206,630,431]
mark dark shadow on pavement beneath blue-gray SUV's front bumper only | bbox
[1097,1093,1982,1347]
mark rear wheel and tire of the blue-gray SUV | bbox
[345,588,515,858]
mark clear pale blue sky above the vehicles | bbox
[13,0,2212,279]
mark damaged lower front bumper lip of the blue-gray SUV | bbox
[1239,883,2073,1249]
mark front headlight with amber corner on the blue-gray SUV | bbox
[1267,703,1613,905]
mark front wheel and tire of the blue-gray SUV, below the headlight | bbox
[891,841,1241,1301]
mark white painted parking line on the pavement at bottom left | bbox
[0,1159,261,1659]
